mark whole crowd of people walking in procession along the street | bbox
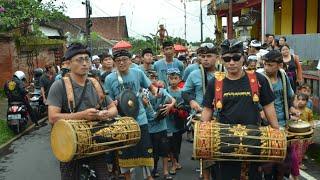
[2,35,313,179]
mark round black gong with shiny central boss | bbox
[118,89,139,118]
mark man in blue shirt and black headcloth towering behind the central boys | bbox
[154,41,184,87]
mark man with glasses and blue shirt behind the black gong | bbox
[104,50,158,179]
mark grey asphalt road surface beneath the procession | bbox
[0,121,320,180]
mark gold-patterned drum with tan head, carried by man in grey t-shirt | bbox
[51,117,141,162]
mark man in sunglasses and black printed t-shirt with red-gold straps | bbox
[202,40,279,180]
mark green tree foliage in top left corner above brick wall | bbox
[0,0,66,32]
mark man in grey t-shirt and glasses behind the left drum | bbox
[47,43,118,180]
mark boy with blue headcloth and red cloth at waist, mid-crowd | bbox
[167,68,188,175]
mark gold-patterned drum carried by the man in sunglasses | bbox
[193,121,287,162]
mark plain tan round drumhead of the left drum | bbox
[51,120,77,162]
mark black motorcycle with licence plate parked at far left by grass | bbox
[7,102,29,134]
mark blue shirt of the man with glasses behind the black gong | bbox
[104,68,151,125]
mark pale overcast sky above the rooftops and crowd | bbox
[51,0,219,42]
